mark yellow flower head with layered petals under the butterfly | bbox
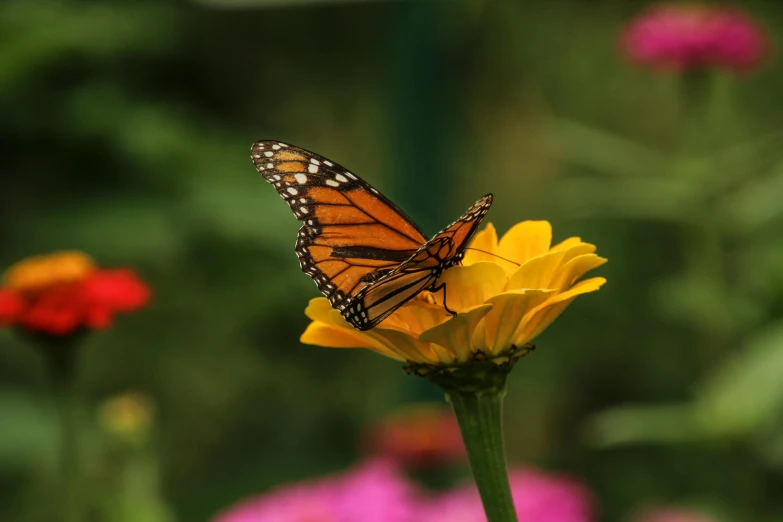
[301,221,606,367]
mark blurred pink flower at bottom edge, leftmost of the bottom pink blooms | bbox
[213,460,420,522]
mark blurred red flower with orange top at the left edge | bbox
[0,251,151,335]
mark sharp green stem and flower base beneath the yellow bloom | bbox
[424,360,530,522]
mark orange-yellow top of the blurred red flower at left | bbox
[4,250,95,293]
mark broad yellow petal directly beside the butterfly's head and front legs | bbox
[434,261,506,312]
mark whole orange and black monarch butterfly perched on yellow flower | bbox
[250,141,492,330]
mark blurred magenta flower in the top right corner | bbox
[622,4,769,72]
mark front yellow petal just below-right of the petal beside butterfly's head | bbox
[473,290,555,354]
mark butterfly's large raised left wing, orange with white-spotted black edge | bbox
[250,141,427,310]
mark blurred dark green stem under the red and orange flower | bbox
[45,343,82,522]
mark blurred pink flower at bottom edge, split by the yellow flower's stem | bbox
[418,469,593,522]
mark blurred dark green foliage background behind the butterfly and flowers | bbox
[0,0,783,522]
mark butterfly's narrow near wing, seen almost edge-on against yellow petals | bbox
[341,194,492,330]
